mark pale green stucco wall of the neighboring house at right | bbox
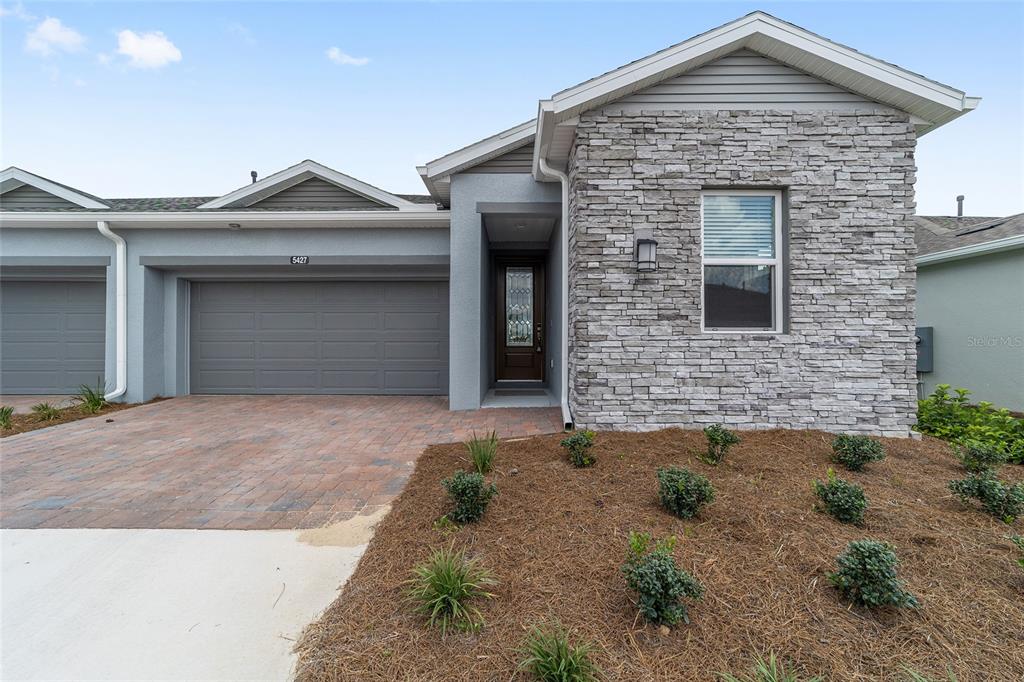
[918,249,1024,411]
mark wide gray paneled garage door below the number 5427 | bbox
[189,282,449,395]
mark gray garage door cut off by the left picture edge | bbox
[0,281,106,395]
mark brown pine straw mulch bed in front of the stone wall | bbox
[297,429,1024,682]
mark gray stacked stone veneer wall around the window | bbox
[569,111,916,436]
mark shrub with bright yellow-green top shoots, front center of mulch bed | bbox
[623,532,703,625]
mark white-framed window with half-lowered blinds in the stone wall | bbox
[700,189,782,333]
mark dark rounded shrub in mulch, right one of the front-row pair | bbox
[828,540,918,607]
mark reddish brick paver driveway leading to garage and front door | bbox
[0,395,560,528]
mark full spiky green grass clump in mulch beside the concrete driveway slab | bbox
[407,548,497,634]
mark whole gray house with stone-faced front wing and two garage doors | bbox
[0,12,978,435]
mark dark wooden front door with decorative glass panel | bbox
[495,259,545,381]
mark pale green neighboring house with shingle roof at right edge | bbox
[915,213,1024,411]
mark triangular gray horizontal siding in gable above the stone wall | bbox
[603,50,889,111]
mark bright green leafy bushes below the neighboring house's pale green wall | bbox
[913,384,1024,464]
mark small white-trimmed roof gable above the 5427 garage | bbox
[198,160,423,210]
